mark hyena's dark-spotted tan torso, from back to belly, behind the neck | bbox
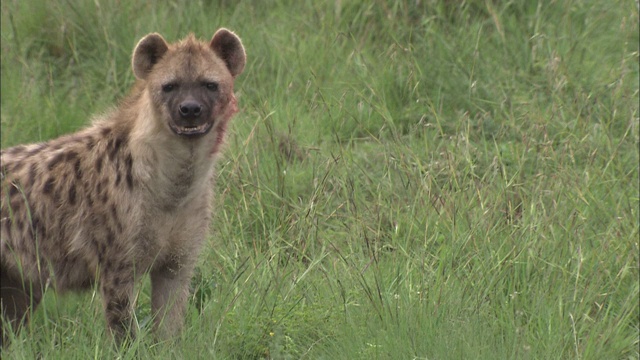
[0,122,136,272]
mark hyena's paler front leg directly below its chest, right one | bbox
[151,262,193,338]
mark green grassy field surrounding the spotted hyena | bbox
[0,0,640,359]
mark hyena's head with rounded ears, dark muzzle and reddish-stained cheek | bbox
[133,29,246,138]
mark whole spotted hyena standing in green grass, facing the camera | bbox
[0,29,246,339]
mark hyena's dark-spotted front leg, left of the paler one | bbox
[100,261,136,341]
